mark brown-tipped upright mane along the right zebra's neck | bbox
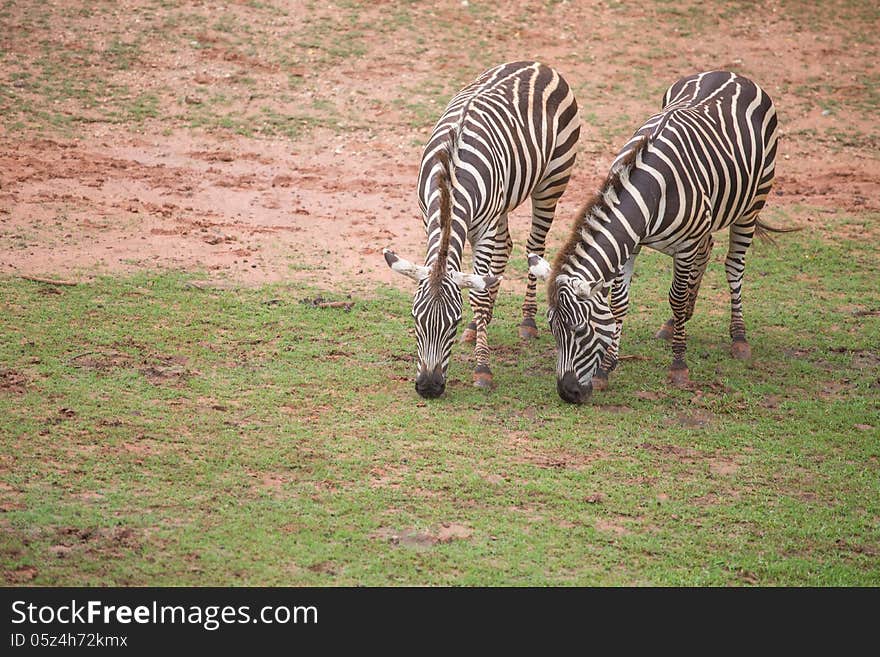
[547,134,651,305]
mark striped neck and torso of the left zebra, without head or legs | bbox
[418,61,580,268]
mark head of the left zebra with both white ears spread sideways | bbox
[383,249,501,399]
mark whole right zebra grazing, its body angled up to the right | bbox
[529,71,784,403]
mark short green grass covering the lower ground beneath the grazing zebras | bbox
[0,217,880,586]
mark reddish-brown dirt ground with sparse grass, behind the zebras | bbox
[0,0,880,292]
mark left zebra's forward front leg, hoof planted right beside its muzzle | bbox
[468,227,513,390]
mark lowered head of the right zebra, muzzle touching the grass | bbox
[529,254,615,404]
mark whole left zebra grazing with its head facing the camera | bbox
[384,62,580,398]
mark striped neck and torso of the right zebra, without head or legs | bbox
[550,71,777,288]
